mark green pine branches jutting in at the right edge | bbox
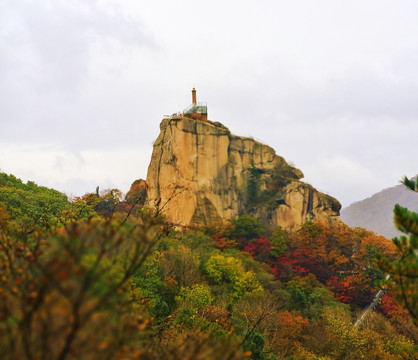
[378,177,418,325]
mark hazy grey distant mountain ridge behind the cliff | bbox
[341,178,418,238]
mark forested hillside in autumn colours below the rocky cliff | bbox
[0,174,418,360]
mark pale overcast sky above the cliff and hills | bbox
[0,0,418,206]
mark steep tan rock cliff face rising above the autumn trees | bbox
[147,118,341,230]
